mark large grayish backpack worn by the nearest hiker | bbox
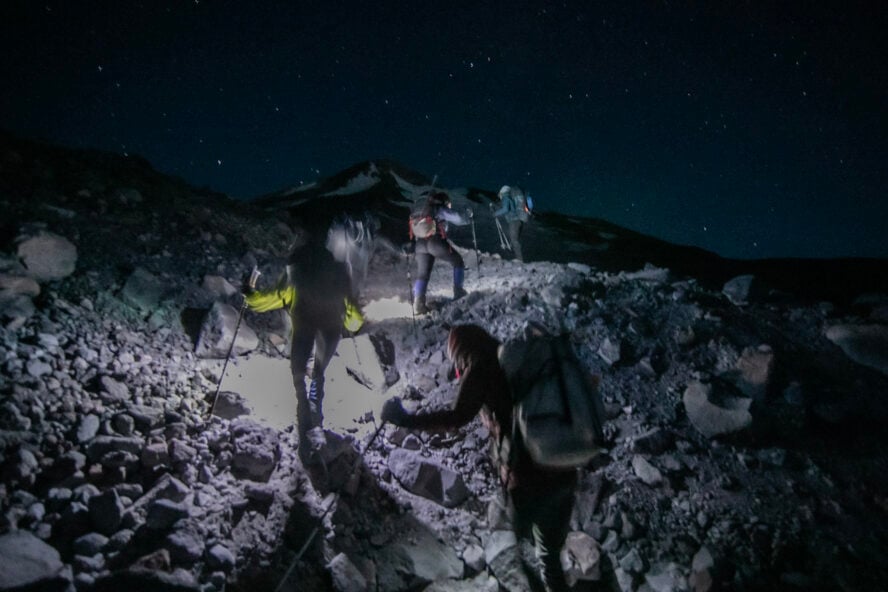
[498,334,604,469]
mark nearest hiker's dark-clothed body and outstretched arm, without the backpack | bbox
[381,325,577,591]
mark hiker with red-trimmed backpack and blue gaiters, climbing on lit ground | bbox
[409,190,472,314]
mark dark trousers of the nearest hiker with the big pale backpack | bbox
[509,471,577,592]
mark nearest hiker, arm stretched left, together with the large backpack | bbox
[381,324,604,591]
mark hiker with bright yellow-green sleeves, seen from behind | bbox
[246,233,364,446]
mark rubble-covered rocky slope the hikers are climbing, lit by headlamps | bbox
[0,134,888,592]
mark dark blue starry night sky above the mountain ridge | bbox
[0,0,888,258]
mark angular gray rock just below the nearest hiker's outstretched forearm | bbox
[388,449,469,508]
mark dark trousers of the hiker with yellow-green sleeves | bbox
[290,314,342,436]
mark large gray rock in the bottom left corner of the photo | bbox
[0,530,69,590]
